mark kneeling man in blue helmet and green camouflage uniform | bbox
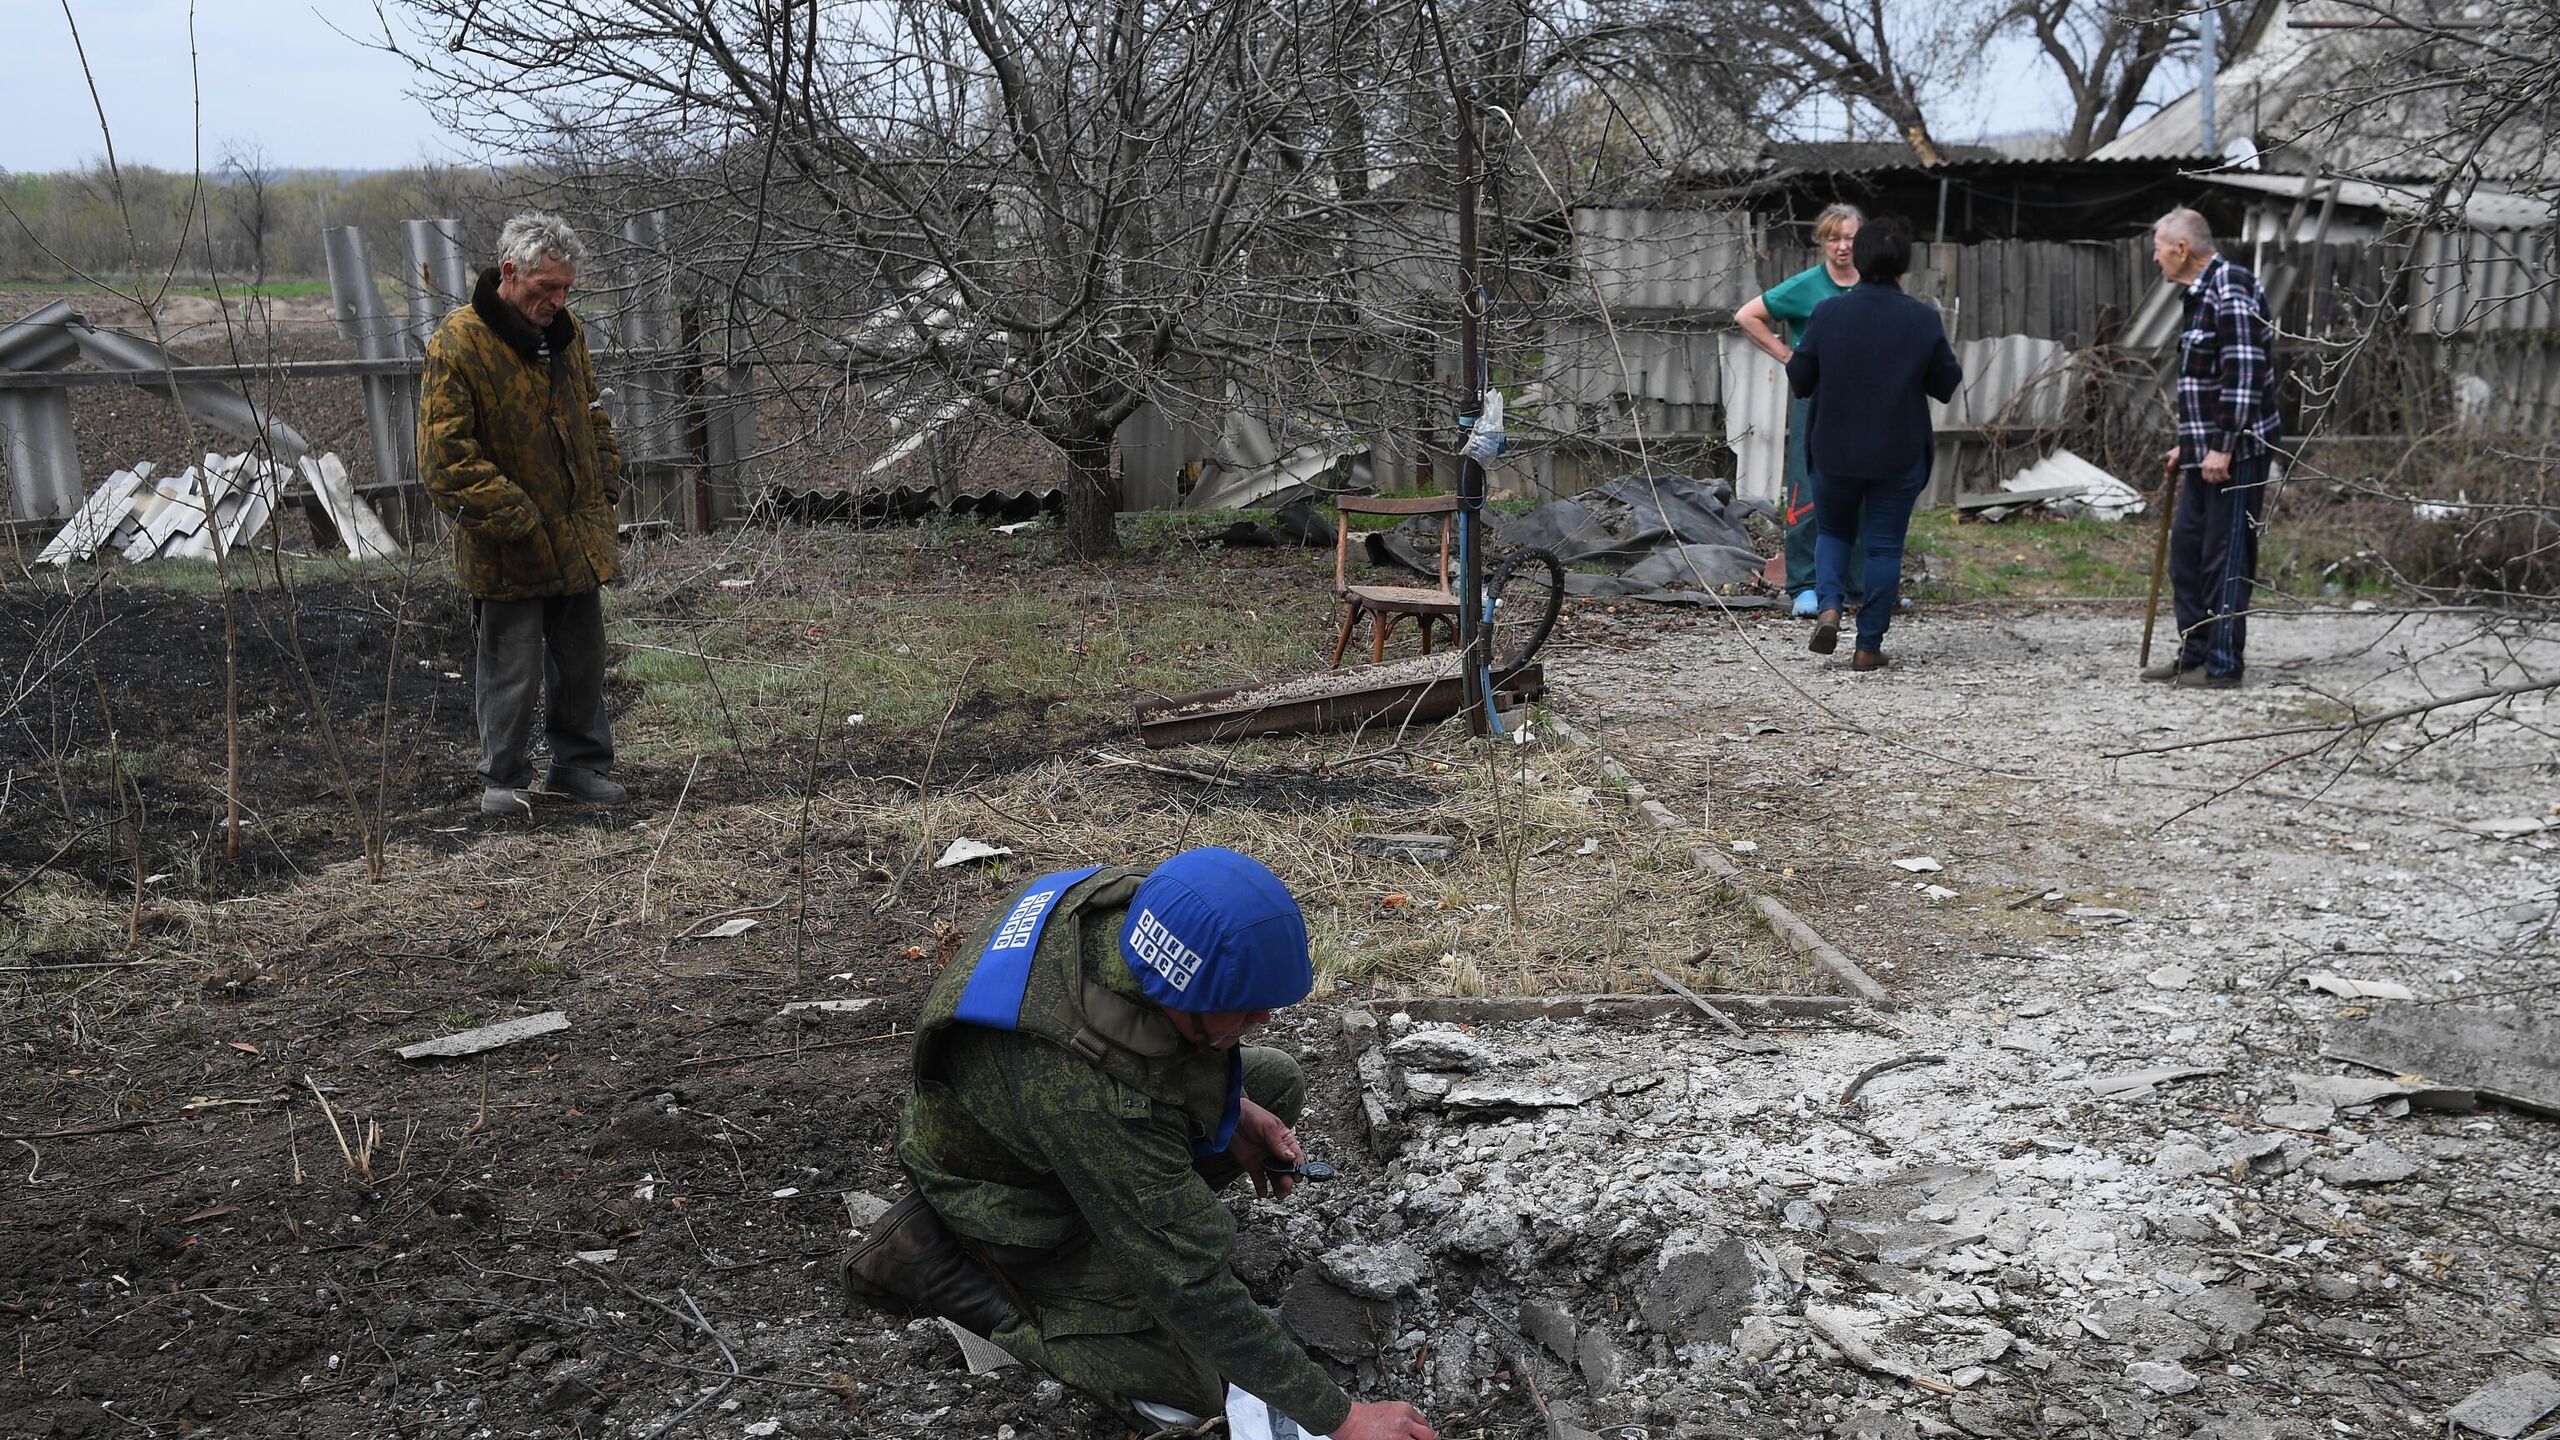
[845,848,1434,1440]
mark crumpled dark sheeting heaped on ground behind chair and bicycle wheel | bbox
[1364,474,1777,597]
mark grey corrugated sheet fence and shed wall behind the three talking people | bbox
[1536,210,2560,500]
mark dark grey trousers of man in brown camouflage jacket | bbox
[471,589,614,789]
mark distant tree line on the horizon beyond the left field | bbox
[0,164,548,287]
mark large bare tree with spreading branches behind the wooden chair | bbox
[373,0,1464,556]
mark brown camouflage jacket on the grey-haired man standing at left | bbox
[417,269,622,600]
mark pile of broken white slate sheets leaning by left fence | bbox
[36,451,399,566]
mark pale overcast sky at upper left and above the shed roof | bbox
[0,0,2119,172]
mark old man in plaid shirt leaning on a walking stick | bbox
[2143,210,2276,689]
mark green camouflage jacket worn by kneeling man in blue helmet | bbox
[899,869,1352,1432]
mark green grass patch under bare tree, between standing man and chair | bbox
[607,515,1334,758]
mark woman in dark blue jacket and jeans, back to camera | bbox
[1787,215,1964,671]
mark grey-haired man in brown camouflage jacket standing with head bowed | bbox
[417,215,625,815]
